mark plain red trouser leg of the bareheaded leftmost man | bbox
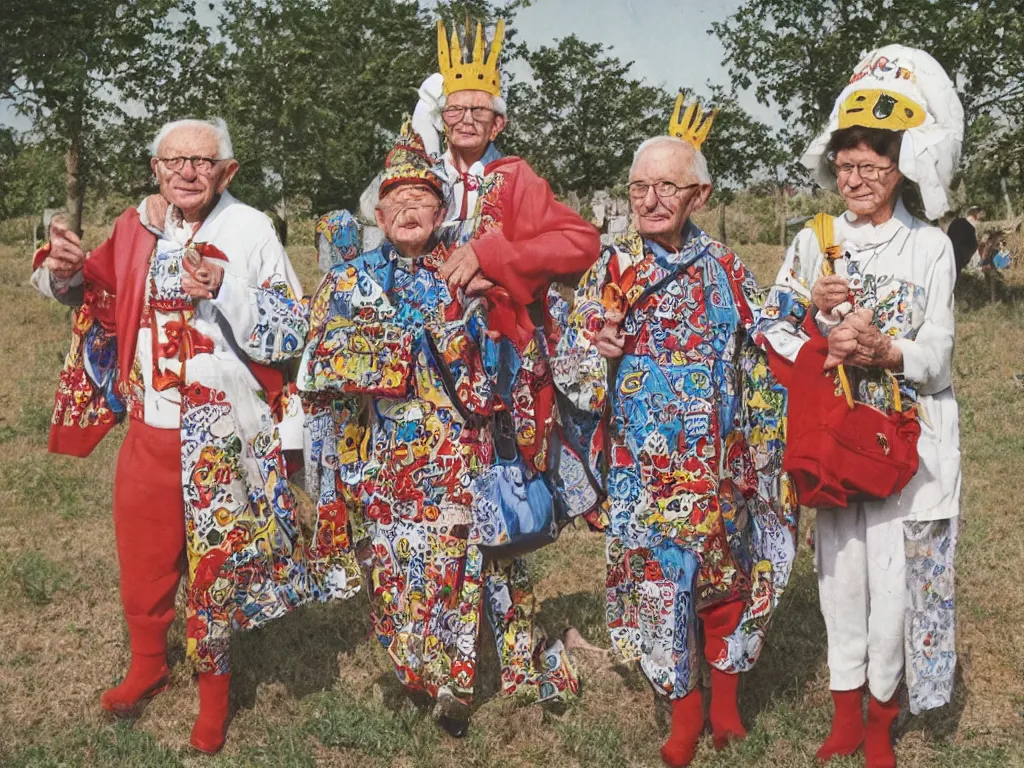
[114,419,185,655]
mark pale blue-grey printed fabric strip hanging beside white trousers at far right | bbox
[903,517,958,715]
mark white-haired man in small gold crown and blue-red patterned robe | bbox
[553,95,797,766]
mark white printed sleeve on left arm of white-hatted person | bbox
[755,229,827,362]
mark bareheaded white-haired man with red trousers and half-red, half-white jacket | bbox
[33,120,358,753]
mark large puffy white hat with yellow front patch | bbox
[801,45,964,219]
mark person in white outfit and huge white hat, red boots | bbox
[761,46,963,768]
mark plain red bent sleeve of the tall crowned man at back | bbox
[470,162,601,304]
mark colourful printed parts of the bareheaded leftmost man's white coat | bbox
[140,240,359,673]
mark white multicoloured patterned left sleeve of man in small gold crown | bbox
[551,248,615,414]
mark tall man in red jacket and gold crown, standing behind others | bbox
[356,22,600,737]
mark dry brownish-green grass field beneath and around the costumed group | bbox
[0,236,1024,768]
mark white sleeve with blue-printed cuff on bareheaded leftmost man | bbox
[211,220,309,365]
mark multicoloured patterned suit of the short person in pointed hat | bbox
[298,244,578,708]
